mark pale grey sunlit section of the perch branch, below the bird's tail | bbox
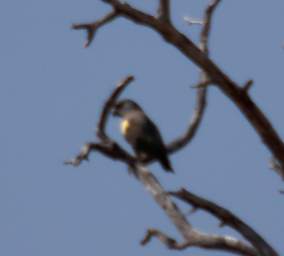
[135,165,258,256]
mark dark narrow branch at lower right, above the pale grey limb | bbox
[170,189,278,256]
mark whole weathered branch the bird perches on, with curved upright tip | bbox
[66,76,258,256]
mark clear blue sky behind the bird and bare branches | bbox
[0,0,284,256]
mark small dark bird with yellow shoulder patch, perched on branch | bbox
[113,99,173,172]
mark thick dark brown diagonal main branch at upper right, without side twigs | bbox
[95,0,284,179]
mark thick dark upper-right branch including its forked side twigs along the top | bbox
[70,0,284,177]
